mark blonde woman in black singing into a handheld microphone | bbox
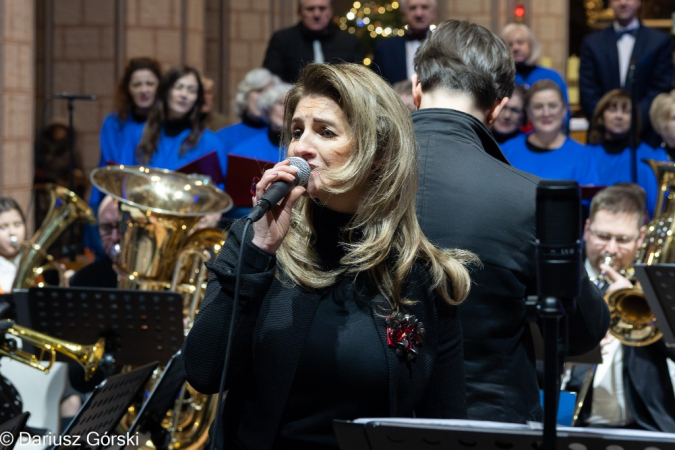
[183,64,476,449]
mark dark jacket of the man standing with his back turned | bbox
[412,108,609,423]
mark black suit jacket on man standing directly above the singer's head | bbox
[263,23,363,83]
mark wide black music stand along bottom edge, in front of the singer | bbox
[333,419,675,450]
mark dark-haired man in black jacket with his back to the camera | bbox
[412,20,609,423]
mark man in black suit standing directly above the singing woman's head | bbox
[263,0,363,83]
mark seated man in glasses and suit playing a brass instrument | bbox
[566,183,675,433]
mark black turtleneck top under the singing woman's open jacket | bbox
[274,204,389,450]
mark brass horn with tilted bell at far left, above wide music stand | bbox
[12,184,96,290]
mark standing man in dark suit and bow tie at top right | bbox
[579,0,674,146]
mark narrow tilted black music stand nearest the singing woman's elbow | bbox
[127,352,185,450]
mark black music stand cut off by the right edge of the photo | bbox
[635,264,675,344]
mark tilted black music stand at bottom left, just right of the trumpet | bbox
[51,362,158,450]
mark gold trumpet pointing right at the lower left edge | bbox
[0,320,105,380]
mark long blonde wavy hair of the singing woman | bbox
[277,64,478,310]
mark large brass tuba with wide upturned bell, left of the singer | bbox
[91,166,232,449]
